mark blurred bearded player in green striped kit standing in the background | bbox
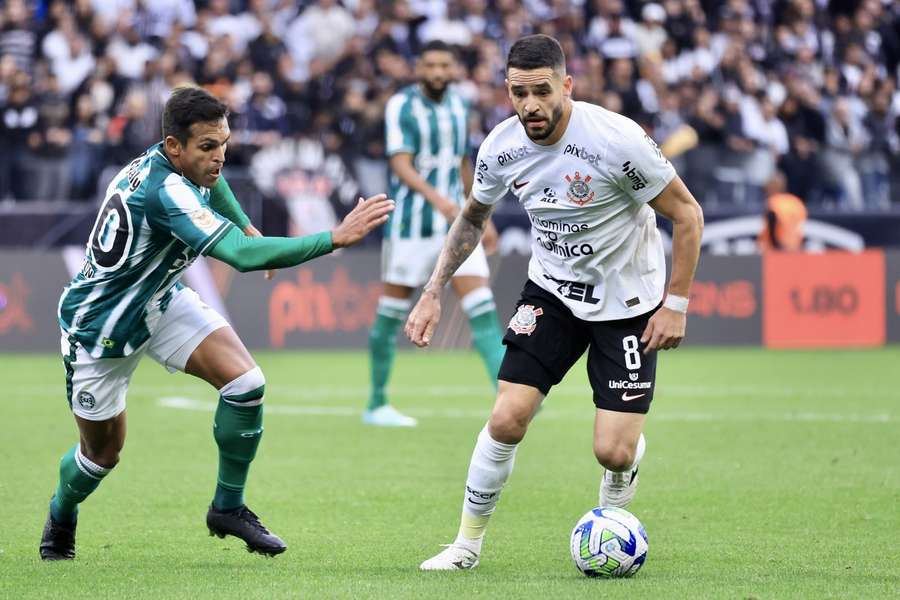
[363,41,503,426]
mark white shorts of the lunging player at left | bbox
[60,288,228,421]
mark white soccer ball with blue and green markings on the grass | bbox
[570,508,648,577]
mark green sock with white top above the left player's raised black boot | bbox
[213,367,266,510]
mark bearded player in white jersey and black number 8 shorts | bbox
[406,35,703,571]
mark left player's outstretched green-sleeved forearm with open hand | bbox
[209,194,394,273]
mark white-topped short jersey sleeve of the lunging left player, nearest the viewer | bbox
[147,174,234,254]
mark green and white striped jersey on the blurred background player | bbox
[385,84,469,239]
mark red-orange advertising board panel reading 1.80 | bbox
[763,250,886,348]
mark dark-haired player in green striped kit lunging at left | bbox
[40,88,393,560]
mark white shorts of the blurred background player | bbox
[381,236,490,288]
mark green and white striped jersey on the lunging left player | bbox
[58,144,233,358]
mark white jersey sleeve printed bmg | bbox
[607,119,675,204]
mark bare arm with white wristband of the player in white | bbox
[641,175,703,354]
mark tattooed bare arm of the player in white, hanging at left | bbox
[404,195,494,347]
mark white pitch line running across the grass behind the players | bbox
[157,397,897,423]
